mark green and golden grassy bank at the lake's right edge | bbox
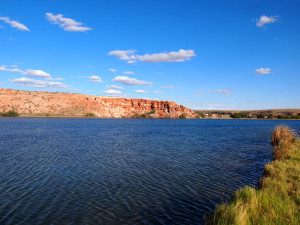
[206,126,300,225]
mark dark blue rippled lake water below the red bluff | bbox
[0,118,300,224]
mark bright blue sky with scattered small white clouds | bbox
[0,0,300,110]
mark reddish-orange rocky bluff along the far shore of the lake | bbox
[0,89,197,118]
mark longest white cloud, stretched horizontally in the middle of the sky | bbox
[108,49,196,63]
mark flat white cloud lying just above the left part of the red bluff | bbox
[12,77,70,90]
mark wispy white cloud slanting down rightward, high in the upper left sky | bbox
[46,13,91,32]
